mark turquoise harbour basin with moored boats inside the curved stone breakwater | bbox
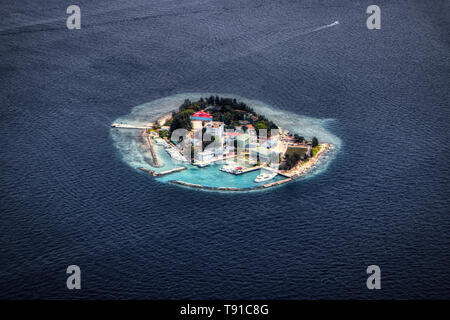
[140,134,331,192]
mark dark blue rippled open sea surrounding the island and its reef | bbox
[0,0,450,299]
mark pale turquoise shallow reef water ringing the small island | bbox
[111,93,342,192]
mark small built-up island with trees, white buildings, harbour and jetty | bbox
[112,95,332,191]
